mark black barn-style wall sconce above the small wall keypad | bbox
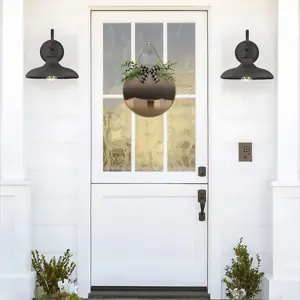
[221,30,274,82]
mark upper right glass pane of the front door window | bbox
[167,23,195,94]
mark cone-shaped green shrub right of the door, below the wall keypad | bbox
[223,238,264,300]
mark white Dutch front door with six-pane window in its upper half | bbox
[91,11,208,287]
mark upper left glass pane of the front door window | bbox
[103,23,131,94]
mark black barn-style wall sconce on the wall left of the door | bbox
[26,29,79,82]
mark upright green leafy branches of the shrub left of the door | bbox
[31,249,76,295]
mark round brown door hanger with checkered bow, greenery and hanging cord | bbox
[122,42,176,117]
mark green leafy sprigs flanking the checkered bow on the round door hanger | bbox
[121,61,176,82]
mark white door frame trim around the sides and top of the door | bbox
[77,5,222,298]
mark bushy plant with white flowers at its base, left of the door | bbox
[31,249,82,300]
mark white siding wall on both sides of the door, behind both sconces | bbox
[25,0,277,296]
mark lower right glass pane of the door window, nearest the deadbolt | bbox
[167,99,196,172]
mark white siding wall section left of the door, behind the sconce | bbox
[25,1,80,278]
